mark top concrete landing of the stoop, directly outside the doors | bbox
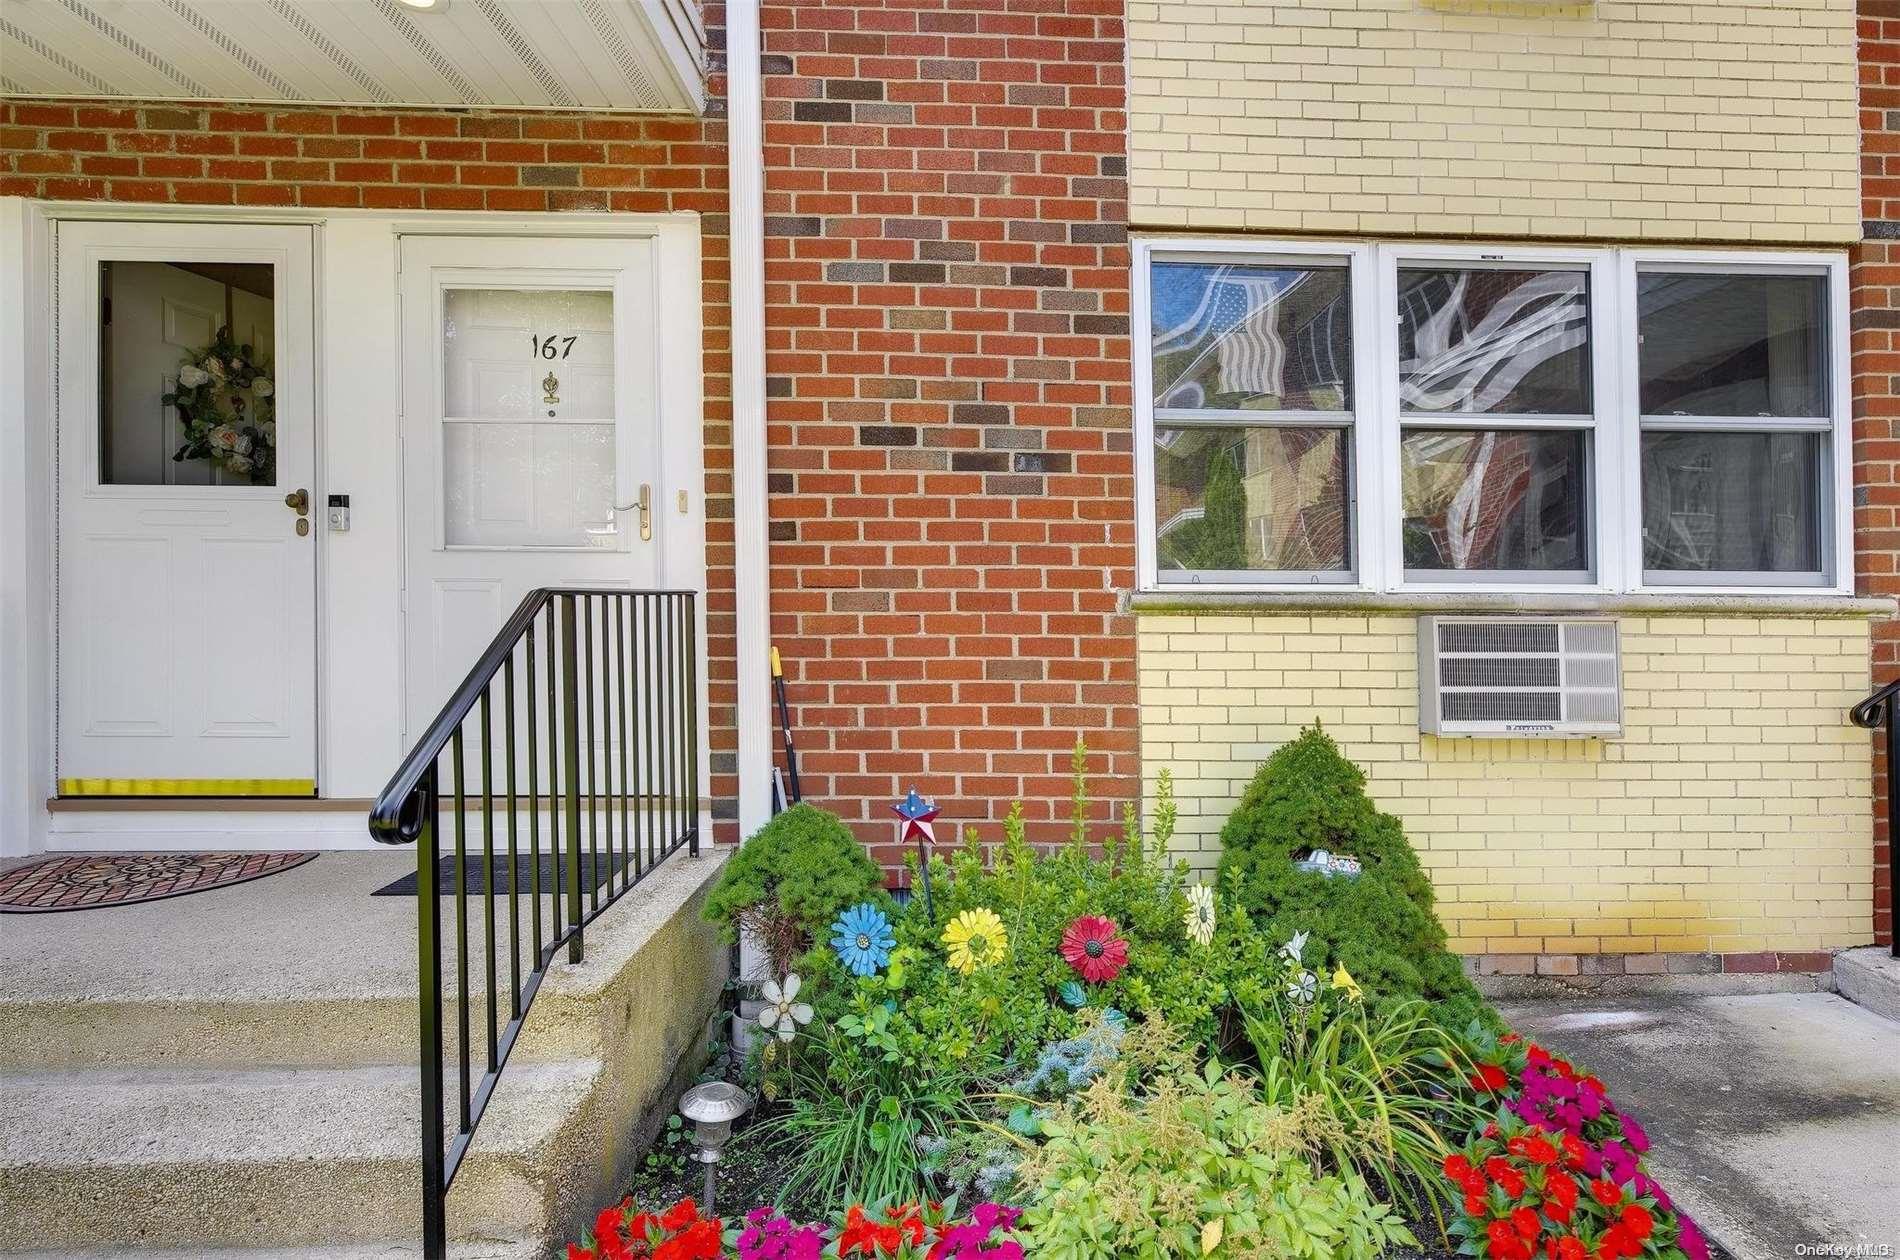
[0,853,716,1072]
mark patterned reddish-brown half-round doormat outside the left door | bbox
[0,853,315,914]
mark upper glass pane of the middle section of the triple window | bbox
[1398,268,1590,416]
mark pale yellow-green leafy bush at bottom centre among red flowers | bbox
[1018,1026,1416,1260]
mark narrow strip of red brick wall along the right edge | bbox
[1853,0,1900,945]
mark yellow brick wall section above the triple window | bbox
[1129,0,1860,241]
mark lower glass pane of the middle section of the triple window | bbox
[1400,430,1590,572]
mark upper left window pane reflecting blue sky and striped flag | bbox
[1151,262,1353,410]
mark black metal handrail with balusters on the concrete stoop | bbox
[369,589,699,1260]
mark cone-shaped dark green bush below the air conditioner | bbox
[1220,728,1497,1028]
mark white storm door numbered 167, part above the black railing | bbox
[403,236,667,741]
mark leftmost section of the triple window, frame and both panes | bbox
[1136,243,1372,589]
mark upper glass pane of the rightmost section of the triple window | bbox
[1636,272,1828,416]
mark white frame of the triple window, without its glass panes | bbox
[1131,238,1854,595]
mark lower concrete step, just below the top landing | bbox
[0,1062,608,1256]
